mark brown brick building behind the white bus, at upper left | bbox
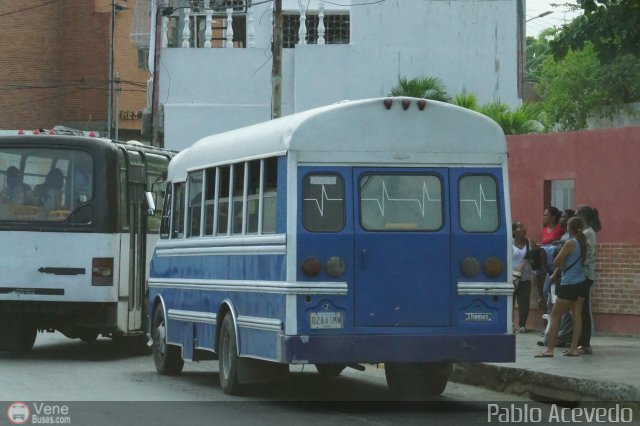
[0,0,149,138]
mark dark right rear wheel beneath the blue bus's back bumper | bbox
[384,363,452,396]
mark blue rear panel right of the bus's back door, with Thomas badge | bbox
[450,168,510,334]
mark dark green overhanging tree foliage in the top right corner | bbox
[551,0,640,63]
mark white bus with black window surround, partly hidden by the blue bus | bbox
[0,135,174,351]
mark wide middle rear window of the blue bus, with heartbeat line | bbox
[360,174,443,231]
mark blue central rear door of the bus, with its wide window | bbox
[353,168,451,327]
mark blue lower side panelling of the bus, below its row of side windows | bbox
[149,251,285,359]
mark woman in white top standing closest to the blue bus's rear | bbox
[511,222,533,333]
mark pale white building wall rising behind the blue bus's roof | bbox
[160,0,520,149]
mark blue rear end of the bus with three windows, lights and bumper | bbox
[288,166,515,365]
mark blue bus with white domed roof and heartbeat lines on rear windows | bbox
[148,98,515,394]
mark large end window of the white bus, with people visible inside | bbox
[0,148,94,222]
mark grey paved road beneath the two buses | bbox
[0,334,526,425]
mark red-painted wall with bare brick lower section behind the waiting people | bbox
[507,127,640,335]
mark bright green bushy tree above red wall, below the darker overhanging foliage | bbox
[538,43,640,130]
